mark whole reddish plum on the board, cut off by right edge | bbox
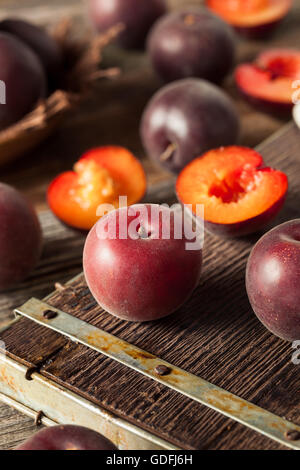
[246,219,300,341]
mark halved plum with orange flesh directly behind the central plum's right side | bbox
[176,146,288,236]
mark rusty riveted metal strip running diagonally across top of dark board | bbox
[15,298,300,450]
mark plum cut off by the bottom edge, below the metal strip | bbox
[15,424,117,450]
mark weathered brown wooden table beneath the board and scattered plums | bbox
[0,0,300,449]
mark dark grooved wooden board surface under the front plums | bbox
[0,125,300,449]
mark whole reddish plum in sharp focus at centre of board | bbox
[83,204,202,322]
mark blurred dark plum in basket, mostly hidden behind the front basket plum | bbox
[0,18,62,84]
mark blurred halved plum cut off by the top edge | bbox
[206,0,292,38]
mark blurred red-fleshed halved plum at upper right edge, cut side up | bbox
[235,49,300,114]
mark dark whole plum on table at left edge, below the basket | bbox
[0,183,42,292]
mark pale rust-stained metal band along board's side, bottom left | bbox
[0,353,180,450]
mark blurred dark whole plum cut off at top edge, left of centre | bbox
[89,0,167,49]
